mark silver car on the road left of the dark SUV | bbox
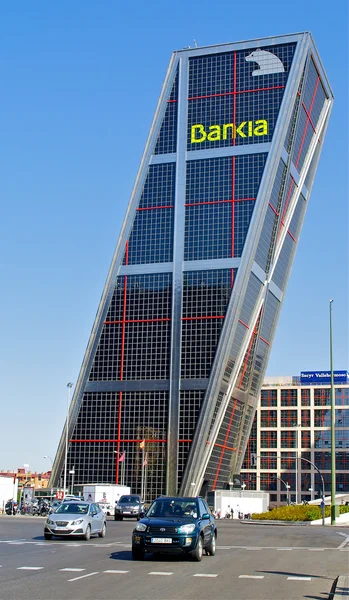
[44,501,107,540]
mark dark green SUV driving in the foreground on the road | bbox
[132,497,217,561]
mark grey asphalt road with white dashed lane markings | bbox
[0,515,349,600]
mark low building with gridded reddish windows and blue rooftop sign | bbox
[241,372,349,506]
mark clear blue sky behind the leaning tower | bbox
[0,0,348,470]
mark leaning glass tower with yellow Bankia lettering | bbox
[51,33,333,500]
